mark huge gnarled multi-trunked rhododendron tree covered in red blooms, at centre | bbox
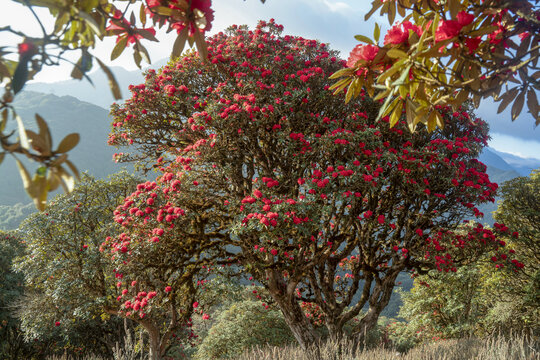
[110,20,520,347]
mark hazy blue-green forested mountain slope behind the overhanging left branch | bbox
[0,91,130,205]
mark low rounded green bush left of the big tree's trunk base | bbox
[195,300,294,360]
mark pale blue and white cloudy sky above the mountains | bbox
[0,0,540,159]
